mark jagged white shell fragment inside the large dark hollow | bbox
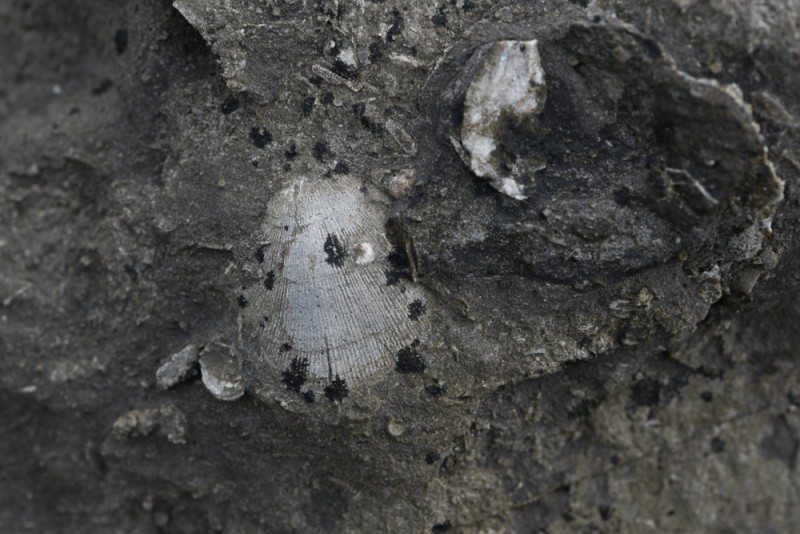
[461,40,546,200]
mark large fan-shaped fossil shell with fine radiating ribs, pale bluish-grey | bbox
[242,176,427,391]
